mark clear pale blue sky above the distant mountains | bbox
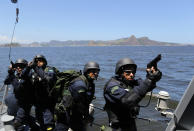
[0,0,194,44]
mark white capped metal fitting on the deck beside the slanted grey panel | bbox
[155,91,173,118]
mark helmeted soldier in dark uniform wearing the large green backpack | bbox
[56,62,100,131]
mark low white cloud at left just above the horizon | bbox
[0,35,33,44]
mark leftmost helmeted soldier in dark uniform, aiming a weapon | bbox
[4,59,38,131]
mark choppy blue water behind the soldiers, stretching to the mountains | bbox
[0,46,194,130]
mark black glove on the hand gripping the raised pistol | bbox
[146,70,162,82]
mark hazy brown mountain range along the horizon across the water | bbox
[0,35,193,47]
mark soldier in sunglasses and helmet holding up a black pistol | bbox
[104,58,162,131]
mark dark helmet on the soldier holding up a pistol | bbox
[115,58,137,75]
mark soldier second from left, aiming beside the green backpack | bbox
[29,55,57,130]
